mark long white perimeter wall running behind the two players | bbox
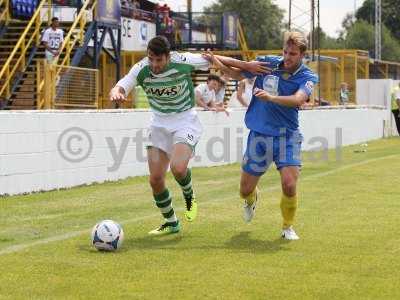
[0,108,388,195]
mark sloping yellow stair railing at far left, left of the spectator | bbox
[0,0,51,99]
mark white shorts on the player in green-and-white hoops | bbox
[147,109,203,155]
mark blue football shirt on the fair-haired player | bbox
[243,55,318,136]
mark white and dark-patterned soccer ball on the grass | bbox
[92,220,124,251]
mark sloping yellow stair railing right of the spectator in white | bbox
[37,0,97,109]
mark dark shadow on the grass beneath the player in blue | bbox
[224,231,289,253]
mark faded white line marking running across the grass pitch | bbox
[0,154,399,256]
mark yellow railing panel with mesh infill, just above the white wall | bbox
[37,59,99,109]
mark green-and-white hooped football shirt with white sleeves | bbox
[117,52,210,114]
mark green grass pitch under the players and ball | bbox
[0,139,400,299]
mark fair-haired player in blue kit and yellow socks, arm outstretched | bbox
[208,32,318,240]
